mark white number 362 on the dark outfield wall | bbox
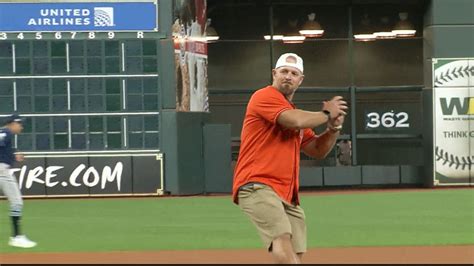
[365,111,410,128]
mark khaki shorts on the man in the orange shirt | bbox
[238,183,306,253]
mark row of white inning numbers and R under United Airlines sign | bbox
[0,31,145,40]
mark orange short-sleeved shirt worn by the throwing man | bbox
[232,86,316,204]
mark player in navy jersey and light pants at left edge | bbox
[0,114,36,248]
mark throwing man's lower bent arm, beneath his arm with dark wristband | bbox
[302,116,344,159]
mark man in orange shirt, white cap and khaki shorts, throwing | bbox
[232,53,347,263]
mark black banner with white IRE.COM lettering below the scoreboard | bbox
[5,154,164,197]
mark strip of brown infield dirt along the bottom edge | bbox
[0,245,474,264]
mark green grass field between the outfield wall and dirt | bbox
[0,189,474,252]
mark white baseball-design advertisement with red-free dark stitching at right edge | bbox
[433,59,474,185]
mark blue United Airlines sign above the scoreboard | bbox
[0,2,158,32]
